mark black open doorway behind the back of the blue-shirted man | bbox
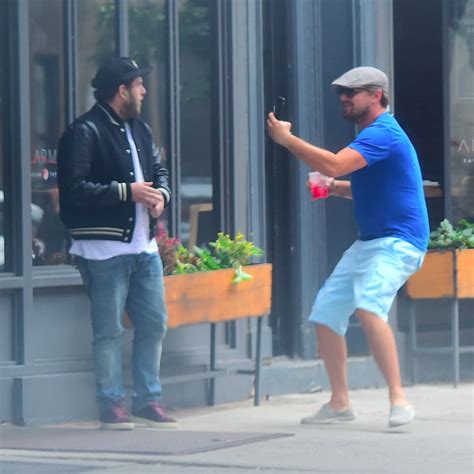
[393,0,446,230]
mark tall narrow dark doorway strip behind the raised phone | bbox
[263,0,297,356]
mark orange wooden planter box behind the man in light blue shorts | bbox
[406,249,474,299]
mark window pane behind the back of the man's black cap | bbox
[77,0,116,115]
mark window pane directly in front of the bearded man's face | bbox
[128,0,169,233]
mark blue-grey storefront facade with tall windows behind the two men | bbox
[0,0,474,423]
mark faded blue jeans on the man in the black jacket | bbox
[77,253,167,410]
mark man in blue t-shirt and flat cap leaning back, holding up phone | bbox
[267,67,429,427]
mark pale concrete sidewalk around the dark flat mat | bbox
[0,384,474,474]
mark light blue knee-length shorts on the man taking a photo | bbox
[309,237,425,336]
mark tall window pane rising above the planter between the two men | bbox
[179,0,218,245]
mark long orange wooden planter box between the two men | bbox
[124,263,272,328]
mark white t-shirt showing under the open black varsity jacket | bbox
[69,122,158,260]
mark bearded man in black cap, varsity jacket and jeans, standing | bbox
[58,57,177,430]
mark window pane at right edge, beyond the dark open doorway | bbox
[449,0,474,222]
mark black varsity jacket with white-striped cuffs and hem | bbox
[57,103,171,242]
